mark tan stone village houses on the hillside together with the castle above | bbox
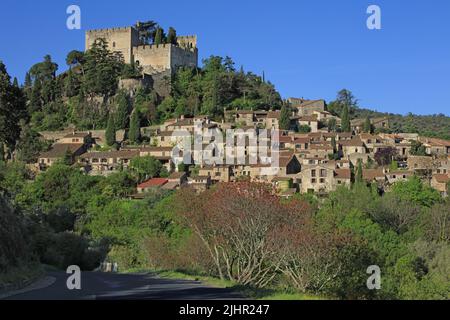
[30,27,450,198]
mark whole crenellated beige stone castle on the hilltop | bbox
[86,27,198,75]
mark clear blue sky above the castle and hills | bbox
[0,0,450,115]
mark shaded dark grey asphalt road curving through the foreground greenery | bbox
[6,272,243,300]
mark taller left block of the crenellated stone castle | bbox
[86,27,139,63]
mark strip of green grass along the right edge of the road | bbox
[123,268,329,300]
